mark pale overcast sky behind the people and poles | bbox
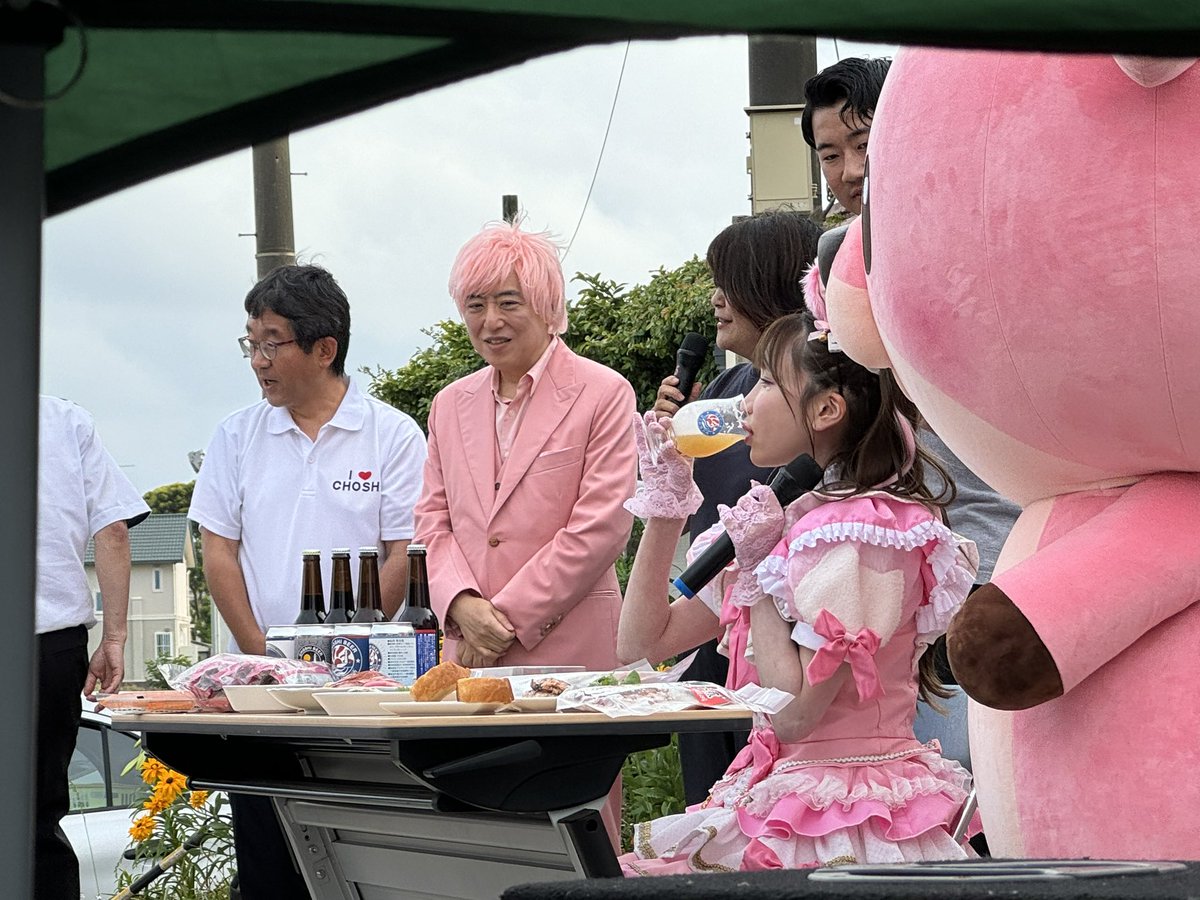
[41,37,894,491]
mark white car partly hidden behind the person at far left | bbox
[62,703,145,900]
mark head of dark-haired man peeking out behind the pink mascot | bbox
[800,58,892,216]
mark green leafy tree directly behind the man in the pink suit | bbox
[362,257,716,430]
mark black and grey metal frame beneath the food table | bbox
[143,716,696,900]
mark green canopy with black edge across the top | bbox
[35,0,1200,215]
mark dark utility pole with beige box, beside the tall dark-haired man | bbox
[746,35,821,214]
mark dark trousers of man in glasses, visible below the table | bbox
[229,793,310,900]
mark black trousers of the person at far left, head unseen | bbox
[34,625,88,900]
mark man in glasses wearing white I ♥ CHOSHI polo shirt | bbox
[188,265,426,900]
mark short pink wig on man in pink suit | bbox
[450,222,566,335]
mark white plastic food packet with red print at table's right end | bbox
[558,682,792,718]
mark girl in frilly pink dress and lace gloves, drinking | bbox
[618,301,978,876]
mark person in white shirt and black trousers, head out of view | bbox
[34,396,150,900]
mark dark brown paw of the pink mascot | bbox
[946,584,1062,709]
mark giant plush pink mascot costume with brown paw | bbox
[828,50,1200,859]
